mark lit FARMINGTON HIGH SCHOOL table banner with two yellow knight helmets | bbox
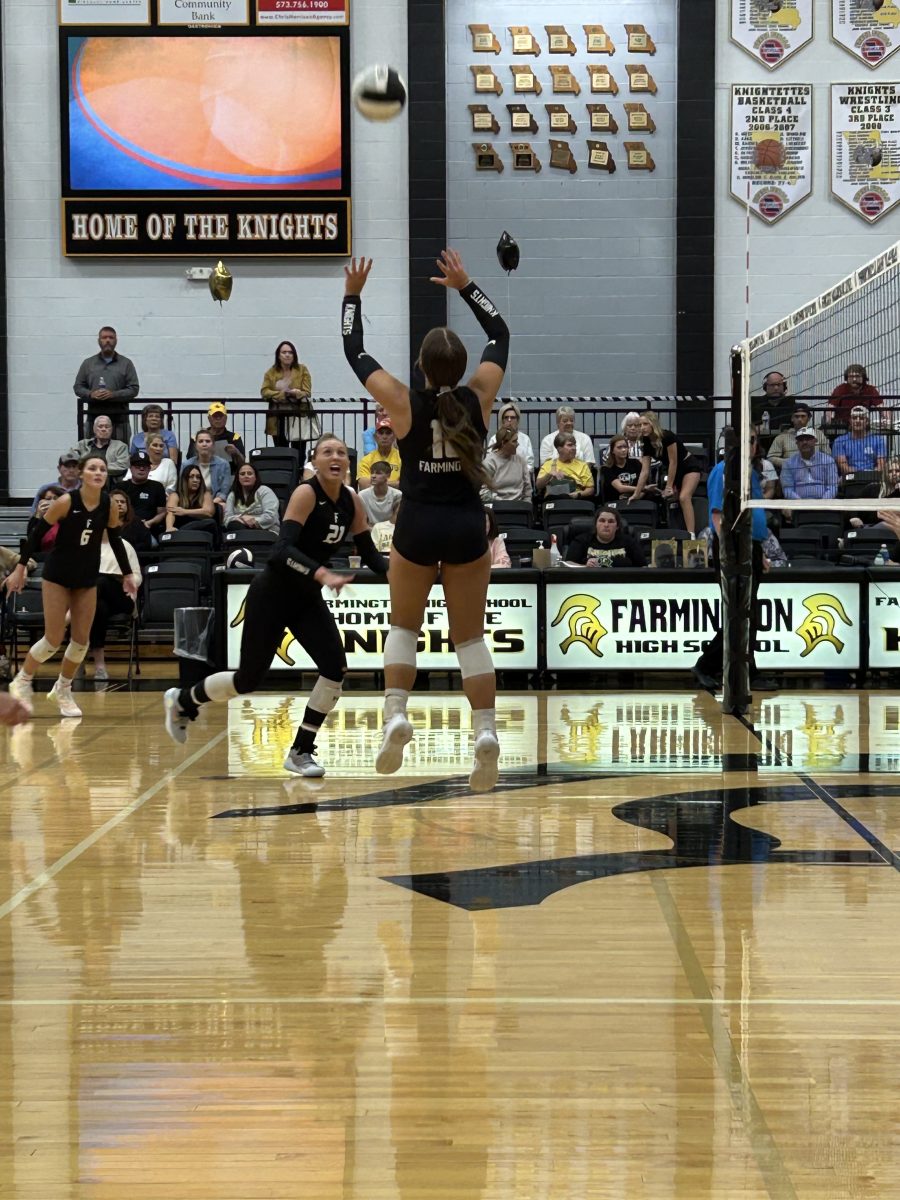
[546,572,860,671]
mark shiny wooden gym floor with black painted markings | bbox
[0,691,900,1200]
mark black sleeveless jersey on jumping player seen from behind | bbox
[397,385,487,508]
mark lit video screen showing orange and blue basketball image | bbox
[66,36,342,193]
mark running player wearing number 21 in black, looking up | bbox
[164,433,388,779]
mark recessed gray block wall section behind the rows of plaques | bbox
[446,0,677,395]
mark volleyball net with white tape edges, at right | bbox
[734,242,900,515]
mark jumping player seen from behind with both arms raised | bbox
[341,250,509,792]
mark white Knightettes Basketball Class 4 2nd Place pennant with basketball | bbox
[731,83,812,224]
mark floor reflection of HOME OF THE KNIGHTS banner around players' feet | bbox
[228,691,544,777]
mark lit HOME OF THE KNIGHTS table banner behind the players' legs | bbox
[226,581,538,671]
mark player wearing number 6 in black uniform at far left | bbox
[6,455,138,716]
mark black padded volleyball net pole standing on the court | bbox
[719,347,754,714]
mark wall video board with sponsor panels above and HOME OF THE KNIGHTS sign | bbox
[59,0,350,258]
